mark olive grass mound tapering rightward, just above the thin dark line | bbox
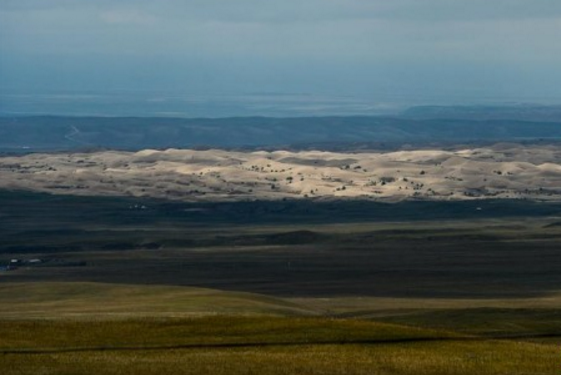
[0,316,448,352]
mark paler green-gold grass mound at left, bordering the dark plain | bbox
[0,282,313,319]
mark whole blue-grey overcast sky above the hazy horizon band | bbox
[0,0,561,108]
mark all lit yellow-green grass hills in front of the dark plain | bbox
[0,283,561,375]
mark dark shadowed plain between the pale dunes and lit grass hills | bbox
[0,192,561,299]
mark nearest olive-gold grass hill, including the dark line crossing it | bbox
[0,317,559,375]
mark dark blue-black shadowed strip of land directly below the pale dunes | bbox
[0,190,561,229]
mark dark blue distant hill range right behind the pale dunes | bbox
[0,106,561,152]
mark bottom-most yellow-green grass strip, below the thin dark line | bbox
[2,341,558,375]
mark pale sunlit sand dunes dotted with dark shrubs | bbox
[0,144,561,201]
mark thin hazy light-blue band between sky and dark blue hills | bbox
[6,90,561,118]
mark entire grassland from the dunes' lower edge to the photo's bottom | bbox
[0,192,561,375]
